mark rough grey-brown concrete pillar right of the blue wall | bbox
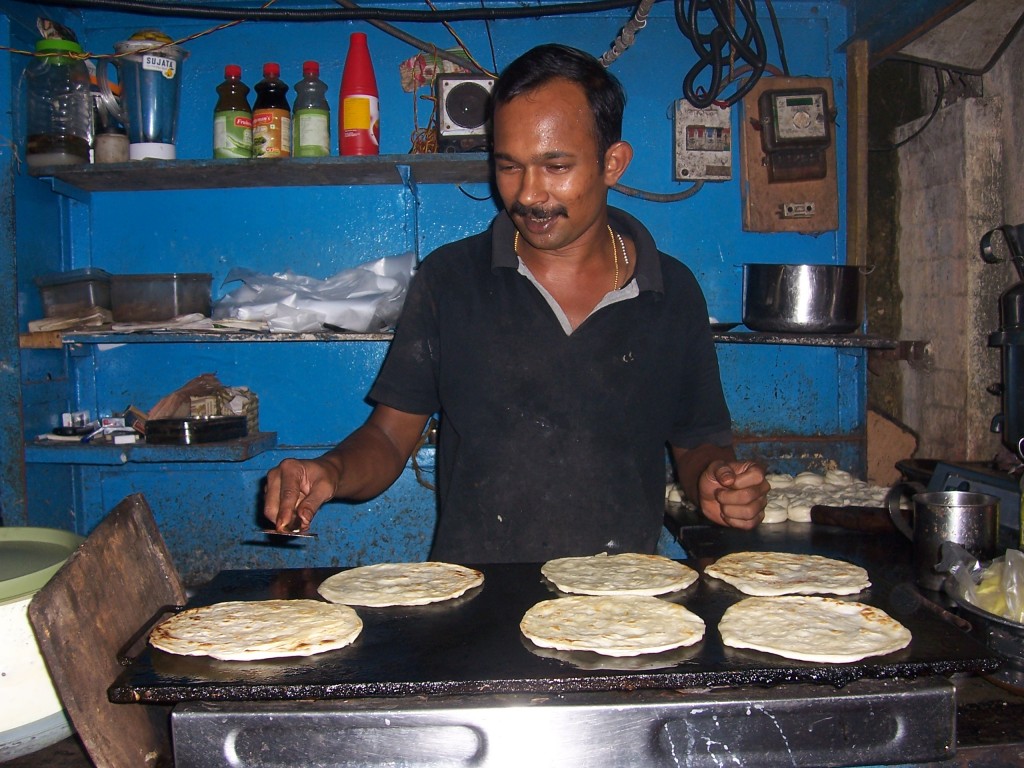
[894,98,1015,461]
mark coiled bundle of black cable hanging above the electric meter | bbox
[675,0,767,110]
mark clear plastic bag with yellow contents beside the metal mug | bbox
[939,542,1024,624]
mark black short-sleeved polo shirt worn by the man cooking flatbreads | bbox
[370,209,731,563]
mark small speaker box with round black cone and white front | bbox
[434,75,495,152]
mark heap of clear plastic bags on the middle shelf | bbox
[213,252,416,333]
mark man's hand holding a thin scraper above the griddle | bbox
[263,458,341,534]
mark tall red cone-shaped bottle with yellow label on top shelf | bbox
[338,32,381,155]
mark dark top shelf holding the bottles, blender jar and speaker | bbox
[31,153,490,191]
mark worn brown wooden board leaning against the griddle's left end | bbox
[29,494,185,768]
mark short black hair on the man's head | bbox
[490,43,626,159]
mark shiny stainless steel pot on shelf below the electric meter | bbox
[743,264,860,334]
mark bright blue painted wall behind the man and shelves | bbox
[0,2,865,574]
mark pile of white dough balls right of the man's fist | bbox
[764,469,889,523]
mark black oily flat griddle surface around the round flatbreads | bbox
[109,531,998,703]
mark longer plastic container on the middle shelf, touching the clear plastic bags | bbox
[111,272,213,323]
